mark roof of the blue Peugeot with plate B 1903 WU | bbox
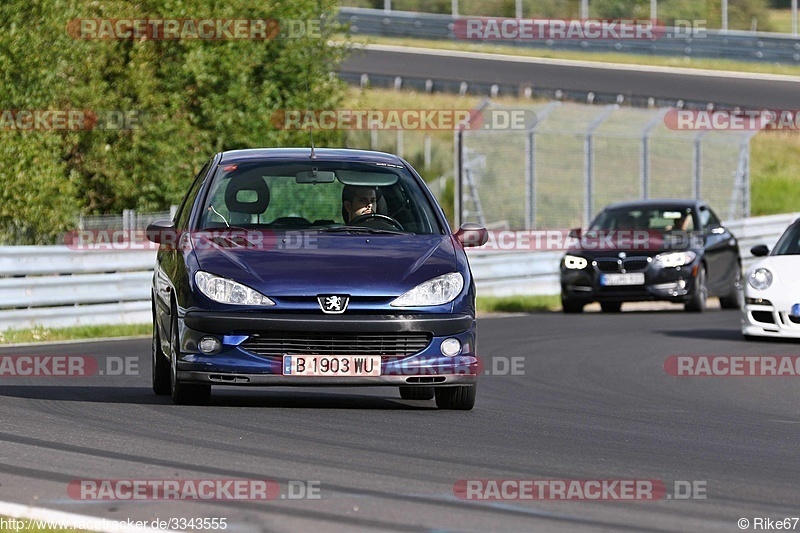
[219,148,403,165]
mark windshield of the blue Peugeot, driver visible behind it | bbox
[194,161,444,235]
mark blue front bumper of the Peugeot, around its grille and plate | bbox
[177,310,479,387]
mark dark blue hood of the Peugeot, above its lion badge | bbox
[192,232,456,297]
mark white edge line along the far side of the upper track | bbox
[358,43,800,83]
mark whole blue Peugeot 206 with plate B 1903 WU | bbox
[147,148,487,410]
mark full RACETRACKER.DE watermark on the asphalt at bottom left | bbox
[67,478,322,501]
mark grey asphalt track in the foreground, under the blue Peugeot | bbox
[0,310,800,532]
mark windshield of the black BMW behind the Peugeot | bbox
[589,206,695,231]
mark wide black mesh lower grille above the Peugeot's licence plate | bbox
[241,331,431,356]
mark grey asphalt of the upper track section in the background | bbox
[339,46,800,109]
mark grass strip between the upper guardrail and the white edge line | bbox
[350,36,800,76]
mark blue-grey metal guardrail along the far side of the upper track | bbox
[339,7,800,65]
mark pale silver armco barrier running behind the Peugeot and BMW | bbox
[0,213,800,330]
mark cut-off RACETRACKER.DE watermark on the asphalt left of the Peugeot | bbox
[0,355,139,379]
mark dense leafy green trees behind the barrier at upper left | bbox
[0,0,346,243]
